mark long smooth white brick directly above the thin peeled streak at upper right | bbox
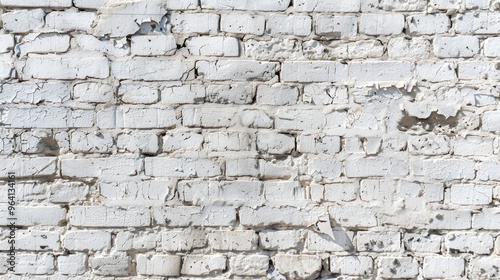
[349,61,413,83]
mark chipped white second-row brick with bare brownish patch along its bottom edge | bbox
[315,15,358,38]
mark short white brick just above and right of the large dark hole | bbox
[415,62,457,83]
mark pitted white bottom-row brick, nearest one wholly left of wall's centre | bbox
[181,255,227,276]
